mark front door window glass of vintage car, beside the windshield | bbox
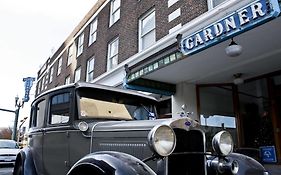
[49,92,70,125]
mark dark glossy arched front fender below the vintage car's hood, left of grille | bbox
[67,151,156,175]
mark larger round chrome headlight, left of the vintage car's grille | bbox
[148,125,176,157]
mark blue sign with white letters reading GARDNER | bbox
[180,0,280,55]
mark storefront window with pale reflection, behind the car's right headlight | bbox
[199,86,237,151]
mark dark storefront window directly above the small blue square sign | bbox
[238,79,274,148]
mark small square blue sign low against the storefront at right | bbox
[260,146,277,163]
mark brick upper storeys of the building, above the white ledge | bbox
[36,0,207,95]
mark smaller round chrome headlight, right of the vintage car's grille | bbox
[212,131,234,156]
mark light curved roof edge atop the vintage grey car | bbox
[34,82,157,104]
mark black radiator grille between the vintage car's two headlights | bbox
[168,129,206,175]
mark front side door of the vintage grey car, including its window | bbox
[43,91,71,175]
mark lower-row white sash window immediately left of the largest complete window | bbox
[107,38,119,70]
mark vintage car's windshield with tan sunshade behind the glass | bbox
[78,87,156,120]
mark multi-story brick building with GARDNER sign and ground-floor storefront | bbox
[36,0,281,163]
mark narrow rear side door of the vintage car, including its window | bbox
[28,98,46,175]
